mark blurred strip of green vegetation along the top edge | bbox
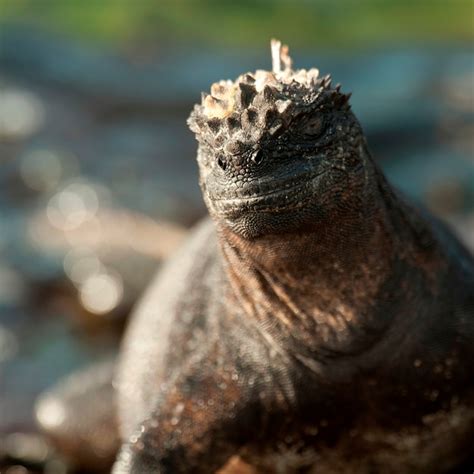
[0,0,474,47]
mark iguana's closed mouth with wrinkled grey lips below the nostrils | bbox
[209,170,327,217]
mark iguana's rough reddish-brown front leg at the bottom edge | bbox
[113,371,259,474]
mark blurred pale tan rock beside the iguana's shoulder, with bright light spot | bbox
[29,206,187,317]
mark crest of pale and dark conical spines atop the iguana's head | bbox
[188,40,350,147]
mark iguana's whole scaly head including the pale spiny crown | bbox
[188,41,367,238]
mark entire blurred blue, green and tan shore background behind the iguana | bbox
[0,0,474,474]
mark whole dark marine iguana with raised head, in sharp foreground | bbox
[113,41,474,474]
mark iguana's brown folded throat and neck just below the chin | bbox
[214,168,409,358]
